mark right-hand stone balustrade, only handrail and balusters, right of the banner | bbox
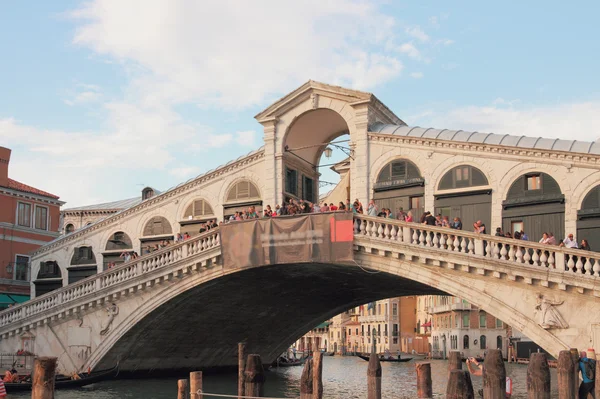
[354,215,600,278]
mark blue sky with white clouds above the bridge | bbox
[0,0,600,208]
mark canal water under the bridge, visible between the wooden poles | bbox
[9,356,558,399]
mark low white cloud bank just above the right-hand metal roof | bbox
[409,102,600,141]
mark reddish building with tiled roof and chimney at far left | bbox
[0,147,63,309]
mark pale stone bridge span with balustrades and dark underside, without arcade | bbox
[0,215,600,372]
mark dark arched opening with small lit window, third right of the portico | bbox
[502,172,565,243]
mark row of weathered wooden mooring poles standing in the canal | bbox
[24,343,600,399]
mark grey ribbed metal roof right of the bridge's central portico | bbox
[369,122,600,155]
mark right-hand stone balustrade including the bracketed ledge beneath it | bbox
[354,215,600,296]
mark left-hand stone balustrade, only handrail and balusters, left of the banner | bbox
[0,229,220,327]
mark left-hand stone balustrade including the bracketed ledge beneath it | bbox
[0,229,220,334]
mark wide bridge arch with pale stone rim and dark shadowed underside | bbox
[83,252,565,369]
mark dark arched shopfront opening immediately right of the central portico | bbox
[373,158,425,222]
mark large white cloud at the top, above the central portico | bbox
[70,0,406,107]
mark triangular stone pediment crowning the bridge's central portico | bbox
[254,80,404,125]
